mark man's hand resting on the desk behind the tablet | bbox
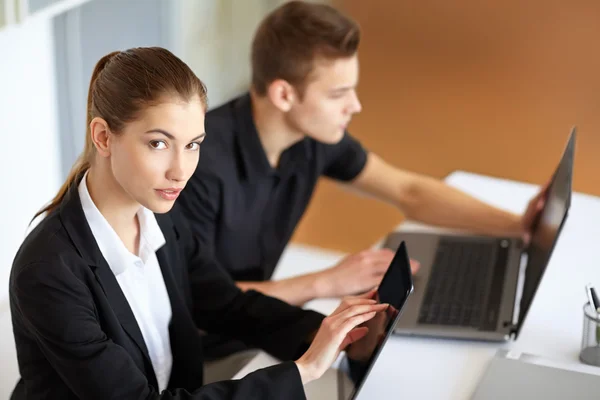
[319,249,420,297]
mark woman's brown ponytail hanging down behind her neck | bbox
[32,51,120,221]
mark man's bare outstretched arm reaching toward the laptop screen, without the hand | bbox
[351,153,524,236]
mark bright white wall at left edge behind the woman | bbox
[0,14,60,399]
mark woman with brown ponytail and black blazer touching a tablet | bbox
[10,48,386,399]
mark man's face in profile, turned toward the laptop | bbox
[286,54,362,144]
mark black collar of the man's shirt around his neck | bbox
[234,94,312,179]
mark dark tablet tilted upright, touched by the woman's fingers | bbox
[338,242,413,400]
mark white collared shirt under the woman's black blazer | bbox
[79,173,173,392]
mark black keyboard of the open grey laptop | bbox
[419,237,509,331]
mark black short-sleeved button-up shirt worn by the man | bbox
[178,94,367,356]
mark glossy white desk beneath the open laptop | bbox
[275,171,600,400]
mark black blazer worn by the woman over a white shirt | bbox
[9,185,323,400]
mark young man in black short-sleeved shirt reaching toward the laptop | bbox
[180,1,540,378]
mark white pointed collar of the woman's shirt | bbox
[78,172,166,276]
